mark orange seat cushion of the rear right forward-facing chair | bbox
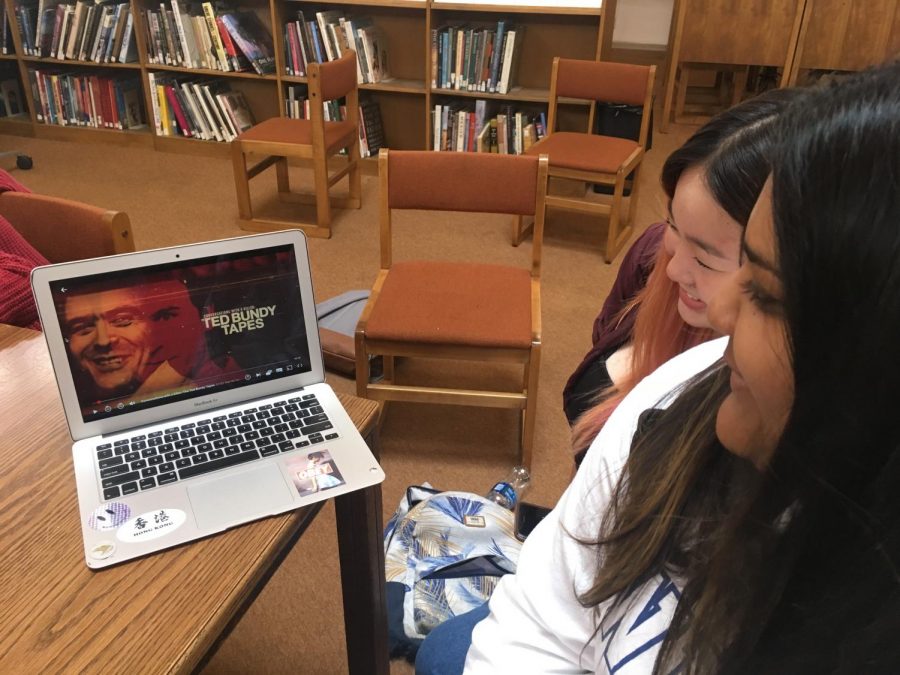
[526,131,639,173]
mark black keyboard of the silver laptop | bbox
[96,394,338,500]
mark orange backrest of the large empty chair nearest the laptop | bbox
[378,148,548,278]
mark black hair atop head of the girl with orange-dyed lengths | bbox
[660,89,801,227]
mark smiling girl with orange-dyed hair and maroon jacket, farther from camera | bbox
[563,89,797,463]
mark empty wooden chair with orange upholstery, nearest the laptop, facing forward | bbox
[355,150,547,466]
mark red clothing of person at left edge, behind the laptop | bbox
[0,170,49,330]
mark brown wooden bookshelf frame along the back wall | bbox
[0,0,614,156]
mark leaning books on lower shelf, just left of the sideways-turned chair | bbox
[148,73,256,143]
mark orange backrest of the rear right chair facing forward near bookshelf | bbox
[547,56,656,147]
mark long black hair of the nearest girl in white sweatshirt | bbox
[725,62,900,673]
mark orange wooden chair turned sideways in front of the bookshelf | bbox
[231,51,360,238]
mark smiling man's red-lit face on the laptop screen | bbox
[65,289,150,394]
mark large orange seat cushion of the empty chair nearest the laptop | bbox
[366,260,531,349]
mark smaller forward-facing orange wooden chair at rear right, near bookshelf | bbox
[513,57,656,262]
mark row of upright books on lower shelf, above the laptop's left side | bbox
[28,69,145,129]
